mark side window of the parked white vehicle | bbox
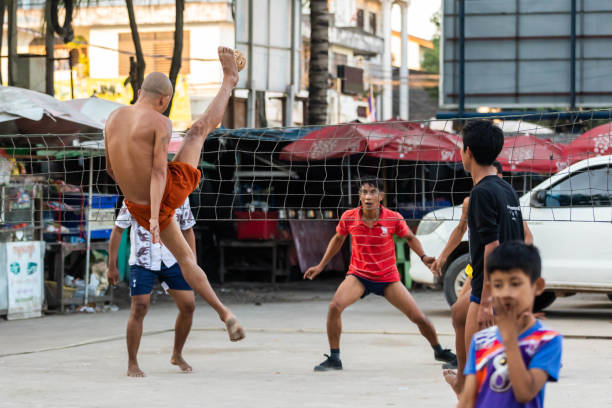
[546,167,612,207]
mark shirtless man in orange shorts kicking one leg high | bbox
[105,47,244,341]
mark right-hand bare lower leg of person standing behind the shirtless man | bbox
[169,290,195,373]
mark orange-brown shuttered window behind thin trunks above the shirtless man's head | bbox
[119,31,190,76]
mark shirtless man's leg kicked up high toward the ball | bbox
[173,47,238,168]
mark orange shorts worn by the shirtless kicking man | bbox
[125,162,200,231]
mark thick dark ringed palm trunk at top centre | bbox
[308,0,329,125]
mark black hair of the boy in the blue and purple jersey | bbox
[487,241,542,283]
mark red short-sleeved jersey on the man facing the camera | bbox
[336,206,410,282]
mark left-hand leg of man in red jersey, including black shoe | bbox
[315,275,365,371]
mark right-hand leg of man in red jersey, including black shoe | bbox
[385,282,456,362]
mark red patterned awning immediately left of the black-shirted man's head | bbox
[368,122,462,162]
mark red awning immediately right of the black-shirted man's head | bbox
[497,135,568,174]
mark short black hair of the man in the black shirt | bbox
[461,120,504,166]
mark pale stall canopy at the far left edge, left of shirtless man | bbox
[0,86,104,134]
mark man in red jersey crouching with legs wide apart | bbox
[304,179,457,371]
